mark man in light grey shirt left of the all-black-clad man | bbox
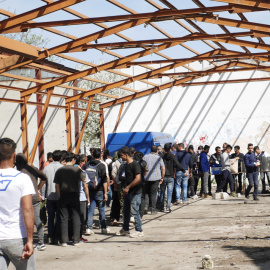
[43,150,63,244]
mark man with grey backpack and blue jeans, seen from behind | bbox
[85,148,110,235]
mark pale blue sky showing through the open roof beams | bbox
[0,0,270,68]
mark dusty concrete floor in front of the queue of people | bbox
[9,195,270,270]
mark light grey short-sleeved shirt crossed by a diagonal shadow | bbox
[143,153,165,181]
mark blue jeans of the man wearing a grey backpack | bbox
[86,191,106,229]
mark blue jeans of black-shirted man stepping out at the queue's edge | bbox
[123,193,142,232]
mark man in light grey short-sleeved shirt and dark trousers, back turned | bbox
[143,145,165,215]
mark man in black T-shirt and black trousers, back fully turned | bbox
[54,152,88,247]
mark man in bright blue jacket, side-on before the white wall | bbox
[199,145,211,198]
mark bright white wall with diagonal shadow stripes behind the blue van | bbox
[104,67,270,153]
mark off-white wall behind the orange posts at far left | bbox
[0,81,75,167]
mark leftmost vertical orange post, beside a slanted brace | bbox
[21,96,30,161]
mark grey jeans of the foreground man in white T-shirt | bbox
[0,238,36,270]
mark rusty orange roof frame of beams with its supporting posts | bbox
[0,0,270,163]
